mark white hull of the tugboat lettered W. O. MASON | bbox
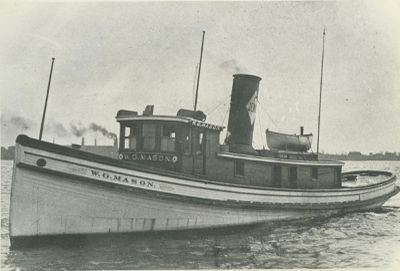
[10,138,396,238]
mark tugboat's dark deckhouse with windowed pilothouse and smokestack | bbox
[116,75,343,189]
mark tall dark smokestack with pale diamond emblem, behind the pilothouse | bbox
[226,74,261,154]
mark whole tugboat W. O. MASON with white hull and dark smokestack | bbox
[9,32,399,245]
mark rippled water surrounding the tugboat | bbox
[1,161,400,270]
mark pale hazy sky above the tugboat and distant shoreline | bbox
[0,0,400,153]
